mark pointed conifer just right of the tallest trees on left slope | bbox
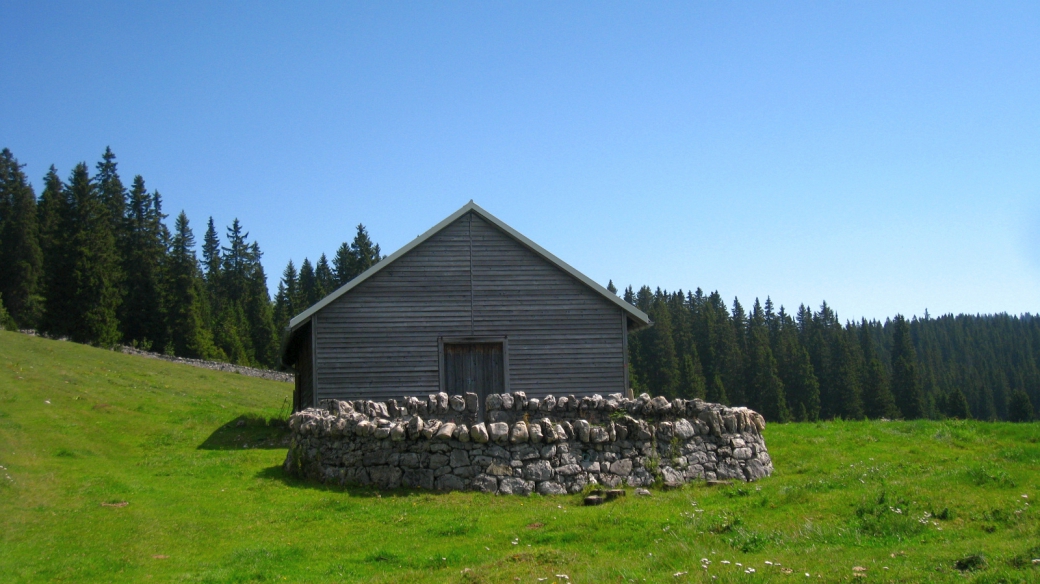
[167,211,220,361]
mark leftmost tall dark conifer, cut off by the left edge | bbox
[0,149,43,328]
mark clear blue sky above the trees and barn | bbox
[0,0,1040,319]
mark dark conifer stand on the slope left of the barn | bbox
[0,149,379,367]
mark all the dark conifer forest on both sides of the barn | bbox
[0,144,1040,422]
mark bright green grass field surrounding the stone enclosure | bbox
[0,331,1040,583]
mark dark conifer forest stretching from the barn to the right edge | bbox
[608,282,1040,422]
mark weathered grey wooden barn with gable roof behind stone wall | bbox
[282,202,650,409]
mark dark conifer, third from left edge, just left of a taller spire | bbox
[67,163,120,347]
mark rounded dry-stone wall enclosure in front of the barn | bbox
[285,392,773,495]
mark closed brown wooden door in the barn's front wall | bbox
[444,343,505,413]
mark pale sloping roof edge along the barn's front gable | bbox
[289,201,650,334]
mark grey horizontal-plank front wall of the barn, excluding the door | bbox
[314,213,625,399]
